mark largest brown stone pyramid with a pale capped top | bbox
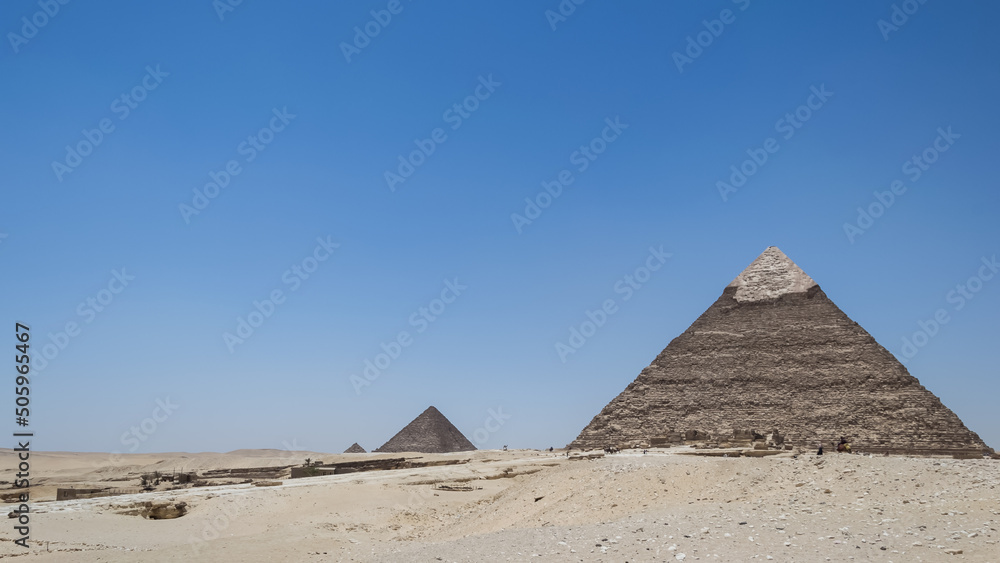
[569,246,989,455]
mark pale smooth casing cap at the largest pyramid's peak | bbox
[728,246,817,303]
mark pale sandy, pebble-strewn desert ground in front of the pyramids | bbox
[0,451,1000,562]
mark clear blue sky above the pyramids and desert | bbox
[0,0,1000,452]
